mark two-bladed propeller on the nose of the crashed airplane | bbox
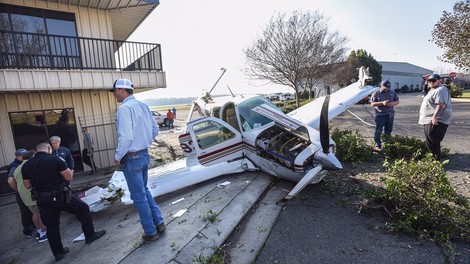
[281,95,332,203]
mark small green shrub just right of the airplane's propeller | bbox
[331,128,373,162]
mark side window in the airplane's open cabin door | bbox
[193,120,236,149]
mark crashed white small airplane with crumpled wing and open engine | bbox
[83,67,378,211]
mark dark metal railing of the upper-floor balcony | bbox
[0,30,162,71]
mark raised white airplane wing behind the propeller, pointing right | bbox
[287,81,379,128]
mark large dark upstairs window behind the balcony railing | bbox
[0,4,81,68]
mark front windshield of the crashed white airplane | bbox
[238,96,277,131]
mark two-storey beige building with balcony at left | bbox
[0,0,166,194]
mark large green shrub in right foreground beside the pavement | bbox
[379,154,470,241]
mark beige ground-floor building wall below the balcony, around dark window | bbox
[0,90,118,169]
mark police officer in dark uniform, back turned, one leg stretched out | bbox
[21,142,106,261]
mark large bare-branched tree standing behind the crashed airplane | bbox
[244,11,346,107]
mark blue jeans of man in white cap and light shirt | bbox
[122,150,163,235]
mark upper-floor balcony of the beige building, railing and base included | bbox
[0,30,166,92]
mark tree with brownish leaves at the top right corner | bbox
[431,0,470,70]
